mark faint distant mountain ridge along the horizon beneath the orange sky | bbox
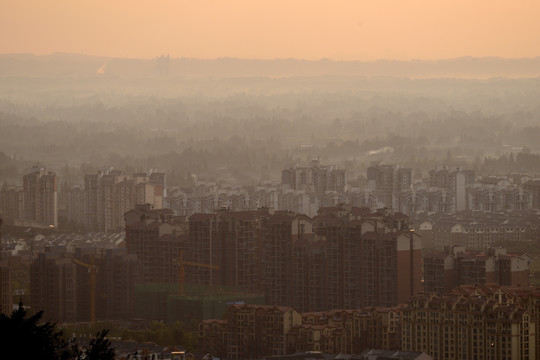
[0,53,540,78]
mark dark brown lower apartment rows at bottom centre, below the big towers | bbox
[199,304,401,359]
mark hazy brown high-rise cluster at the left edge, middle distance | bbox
[0,167,166,232]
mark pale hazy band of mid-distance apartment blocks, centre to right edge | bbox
[166,160,540,217]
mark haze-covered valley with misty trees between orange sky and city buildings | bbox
[0,54,540,185]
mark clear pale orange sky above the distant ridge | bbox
[0,0,540,60]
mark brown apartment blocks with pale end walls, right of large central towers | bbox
[424,246,531,294]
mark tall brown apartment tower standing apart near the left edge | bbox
[23,167,58,226]
